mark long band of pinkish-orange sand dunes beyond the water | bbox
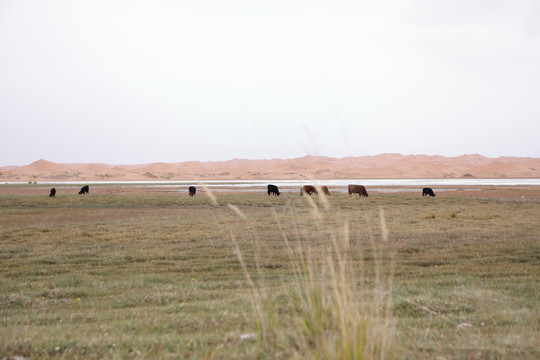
[0,154,540,181]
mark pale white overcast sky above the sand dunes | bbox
[0,0,540,165]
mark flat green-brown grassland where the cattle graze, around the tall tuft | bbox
[0,191,540,359]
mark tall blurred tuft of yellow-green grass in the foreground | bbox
[231,201,397,360]
